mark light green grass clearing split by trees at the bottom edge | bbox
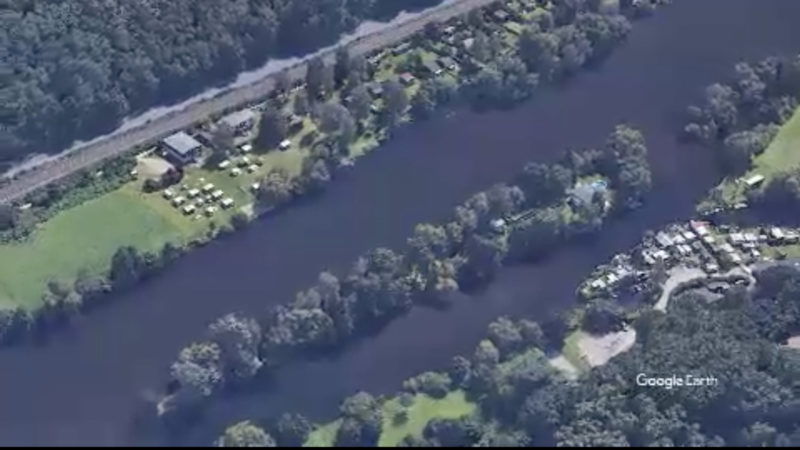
[305,391,476,447]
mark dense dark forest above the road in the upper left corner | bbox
[0,0,441,161]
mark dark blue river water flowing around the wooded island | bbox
[0,0,800,445]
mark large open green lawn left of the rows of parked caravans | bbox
[0,188,184,309]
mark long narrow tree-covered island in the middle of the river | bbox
[159,125,650,418]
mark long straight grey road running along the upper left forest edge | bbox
[0,0,495,203]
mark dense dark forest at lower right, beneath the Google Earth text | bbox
[242,265,800,447]
